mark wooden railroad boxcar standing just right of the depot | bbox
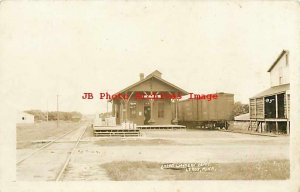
[177,92,234,129]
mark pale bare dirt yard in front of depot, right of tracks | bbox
[17,124,289,181]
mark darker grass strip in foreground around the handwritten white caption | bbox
[101,160,290,181]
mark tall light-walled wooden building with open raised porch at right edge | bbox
[250,50,290,134]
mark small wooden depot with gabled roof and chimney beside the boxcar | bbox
[112,70,188,125]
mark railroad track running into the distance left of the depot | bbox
[16,125,89,181]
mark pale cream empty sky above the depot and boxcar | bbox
[0,1,300,114]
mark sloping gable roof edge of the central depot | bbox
[116,70,189,95]
